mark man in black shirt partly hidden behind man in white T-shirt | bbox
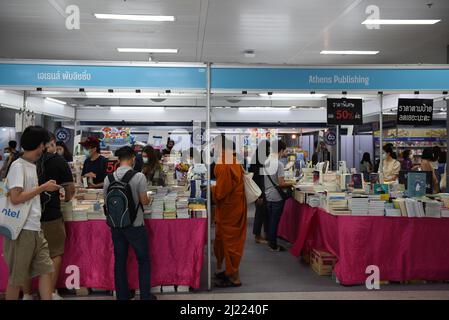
[24,133,75,300]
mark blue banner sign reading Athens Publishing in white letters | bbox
[211,68,449,90]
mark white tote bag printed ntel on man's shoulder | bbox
[0,162,32,240]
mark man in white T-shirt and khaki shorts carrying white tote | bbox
[3,126,60,300]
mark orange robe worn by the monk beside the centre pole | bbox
[212,158,246,276]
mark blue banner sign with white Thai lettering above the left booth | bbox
[0,63,207,89]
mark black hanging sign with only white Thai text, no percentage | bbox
[397,99,433,126]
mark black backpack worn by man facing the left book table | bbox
[104,170,140,228]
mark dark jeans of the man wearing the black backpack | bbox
[111,226,151,300]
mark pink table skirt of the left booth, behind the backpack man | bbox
[0,219,207,292]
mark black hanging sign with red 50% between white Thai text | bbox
[327,98,363,125]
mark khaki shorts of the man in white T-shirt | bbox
[3,230,55,286]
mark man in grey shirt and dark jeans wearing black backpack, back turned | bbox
[103,147,156,300]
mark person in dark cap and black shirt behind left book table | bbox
[80,137,106,188]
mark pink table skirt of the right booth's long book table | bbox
[279,199,449,285]
